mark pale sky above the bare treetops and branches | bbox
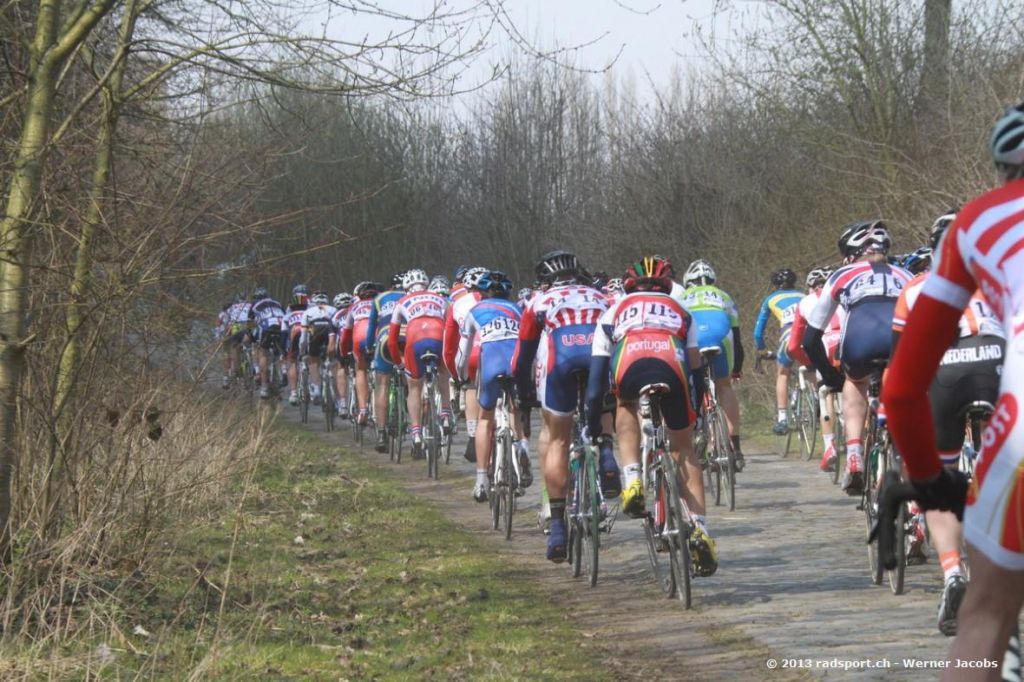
[311,0,760,100]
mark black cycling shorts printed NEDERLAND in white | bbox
[928,336,1006,453]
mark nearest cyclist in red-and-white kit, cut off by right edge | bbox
[883,103,1024,680]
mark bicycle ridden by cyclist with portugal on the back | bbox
[639,384,693,608]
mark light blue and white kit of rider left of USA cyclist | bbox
[459,298,522,410]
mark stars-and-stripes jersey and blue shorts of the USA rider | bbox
[513,284,608,416]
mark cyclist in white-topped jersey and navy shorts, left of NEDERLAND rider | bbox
[803,220,910,495]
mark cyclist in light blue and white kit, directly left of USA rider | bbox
[459,270,534,502]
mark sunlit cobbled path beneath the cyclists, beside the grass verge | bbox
[281,399,949,680]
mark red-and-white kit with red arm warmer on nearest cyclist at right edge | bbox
[885,179,1024,570]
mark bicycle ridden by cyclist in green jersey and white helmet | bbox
[697,346,736,511]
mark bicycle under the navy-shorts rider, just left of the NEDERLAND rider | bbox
[860,359,911,594]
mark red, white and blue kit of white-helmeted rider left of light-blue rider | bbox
[387,290,447,379]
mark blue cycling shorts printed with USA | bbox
[537,325,595,417]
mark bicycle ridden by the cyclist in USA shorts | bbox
[566,373,609,587]
